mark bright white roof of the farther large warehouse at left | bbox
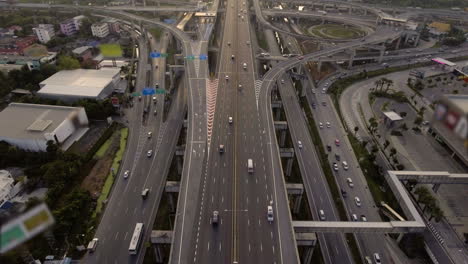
[38,68,120,97]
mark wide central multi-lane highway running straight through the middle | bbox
[177,0,299,263]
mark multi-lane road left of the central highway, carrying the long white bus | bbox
[84,27,185,263]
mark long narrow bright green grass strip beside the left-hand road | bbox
[93,128,128,218]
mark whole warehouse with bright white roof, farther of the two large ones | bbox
[37,68,120,102]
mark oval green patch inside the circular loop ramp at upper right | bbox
[308,24,365,39]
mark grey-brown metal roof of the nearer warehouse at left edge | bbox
[0,103,82,139]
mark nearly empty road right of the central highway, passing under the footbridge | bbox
[265,29,353,263]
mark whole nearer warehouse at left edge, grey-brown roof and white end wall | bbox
[0,103,89,151]
